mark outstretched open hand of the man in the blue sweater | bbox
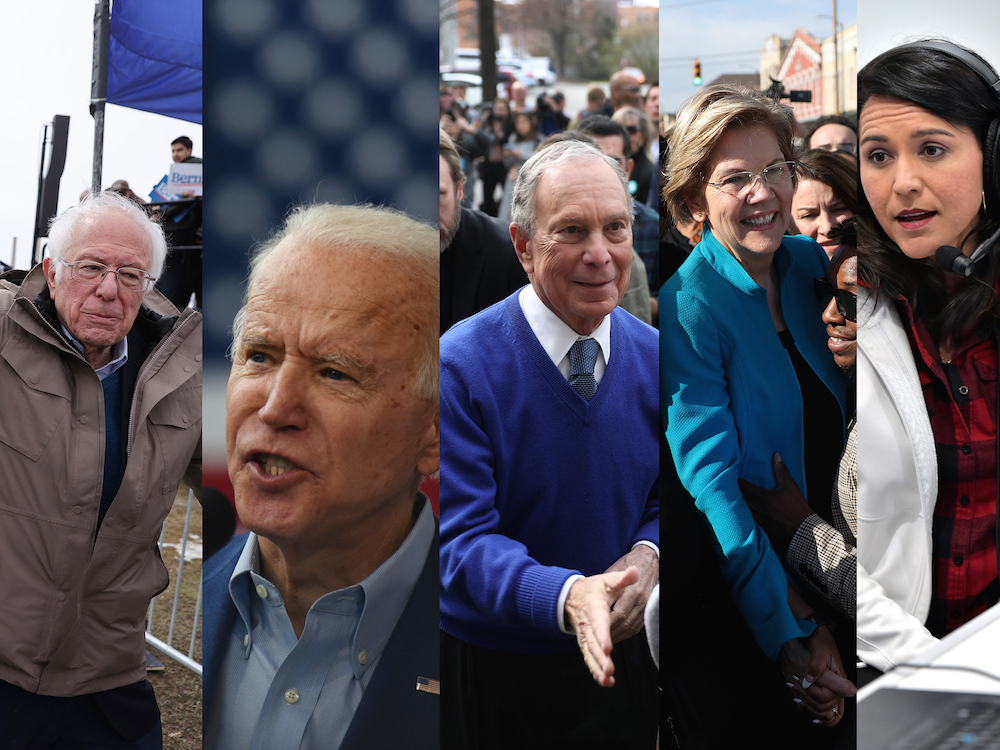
[566,566,641,687]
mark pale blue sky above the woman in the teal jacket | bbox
[660,0,860,112]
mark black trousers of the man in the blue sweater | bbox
[441,631,659,750]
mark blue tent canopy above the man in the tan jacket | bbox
[107,0,202,124]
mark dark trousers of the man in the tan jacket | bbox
[0,681,163,750]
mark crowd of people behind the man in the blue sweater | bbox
[440,72,660,333]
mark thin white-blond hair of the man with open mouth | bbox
[233,203,441,401]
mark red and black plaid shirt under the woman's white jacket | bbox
[898,299,1000,636]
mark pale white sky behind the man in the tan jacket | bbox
[0,0,203,268]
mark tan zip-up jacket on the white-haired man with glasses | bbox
[0,265,202,696]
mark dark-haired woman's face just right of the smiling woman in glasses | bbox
[788,150,858,258]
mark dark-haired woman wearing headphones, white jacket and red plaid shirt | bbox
[858,40,1000,671]
